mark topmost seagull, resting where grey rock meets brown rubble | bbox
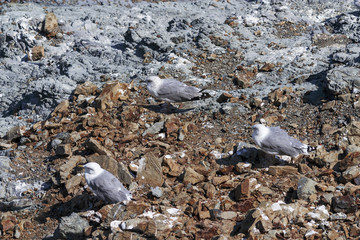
[145,76,210,102]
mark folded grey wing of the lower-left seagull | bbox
[89,170,131,203]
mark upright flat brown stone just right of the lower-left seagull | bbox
[136,153,164,187]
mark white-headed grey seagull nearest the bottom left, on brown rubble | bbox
[84,162,131,204]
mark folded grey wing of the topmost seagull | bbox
[157,79,201,102]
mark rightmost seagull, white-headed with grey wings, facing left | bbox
[252,124,311,158]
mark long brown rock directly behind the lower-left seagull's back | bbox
[86,154,133,185]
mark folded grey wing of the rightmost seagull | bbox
[261,127,306,157]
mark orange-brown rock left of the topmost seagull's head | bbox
[95,82,129,111]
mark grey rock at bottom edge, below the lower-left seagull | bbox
[58,213,90,239]
